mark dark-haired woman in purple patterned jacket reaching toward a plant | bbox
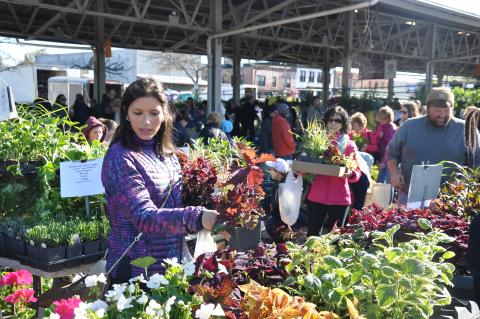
[102,79,217,283]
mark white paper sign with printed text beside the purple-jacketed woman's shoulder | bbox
[60,158,105,197]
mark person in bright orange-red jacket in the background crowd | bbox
[272,103,296,160]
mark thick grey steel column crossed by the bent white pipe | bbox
[207,0,222,113]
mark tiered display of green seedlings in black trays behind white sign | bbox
[0,106,109,272]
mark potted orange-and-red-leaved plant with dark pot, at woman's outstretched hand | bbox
[217,143,275,251]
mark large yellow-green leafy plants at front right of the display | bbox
[285,219,455,319]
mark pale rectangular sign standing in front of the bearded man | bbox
[407,163,443,209]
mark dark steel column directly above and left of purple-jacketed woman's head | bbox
[93,0,105,104]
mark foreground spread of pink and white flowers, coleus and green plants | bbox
[0,218,462,319]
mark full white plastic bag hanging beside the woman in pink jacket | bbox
[278,170,303,226]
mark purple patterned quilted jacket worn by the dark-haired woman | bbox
[102,138,202,276]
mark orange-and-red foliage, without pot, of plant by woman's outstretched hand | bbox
[217,143,275,229]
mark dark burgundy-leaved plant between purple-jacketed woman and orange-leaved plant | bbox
[177,152,217,208]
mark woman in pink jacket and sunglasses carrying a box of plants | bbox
[307,106,361,236]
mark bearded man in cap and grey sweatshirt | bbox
[387,87,480,204]
